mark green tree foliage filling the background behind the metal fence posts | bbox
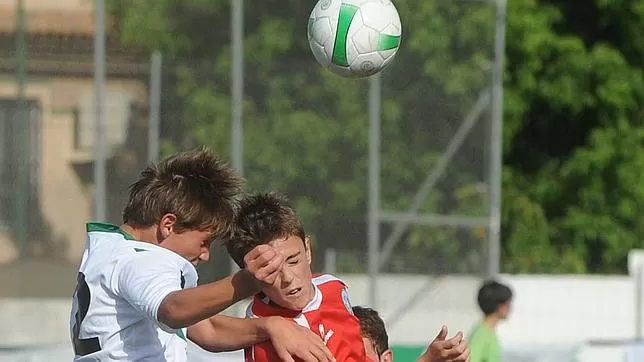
[108,0,644,273]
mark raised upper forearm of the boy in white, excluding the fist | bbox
[157,270,256,328]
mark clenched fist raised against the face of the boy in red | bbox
[244,244,284,288]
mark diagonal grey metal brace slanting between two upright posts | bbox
[380,89,490,266]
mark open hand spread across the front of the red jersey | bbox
[266,317,335,362]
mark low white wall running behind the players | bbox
[0,275,644,362]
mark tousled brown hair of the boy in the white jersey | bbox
[123,148,243,238]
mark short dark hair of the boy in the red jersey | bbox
[226,193,306,268]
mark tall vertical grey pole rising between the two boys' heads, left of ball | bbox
[230,0,244,272]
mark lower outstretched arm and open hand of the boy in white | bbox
[188,316,334,362]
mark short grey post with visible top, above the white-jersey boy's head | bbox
[148,51,163,162]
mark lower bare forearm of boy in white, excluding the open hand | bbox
[188,316,270,352]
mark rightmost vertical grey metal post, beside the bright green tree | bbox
[486,0,507,277]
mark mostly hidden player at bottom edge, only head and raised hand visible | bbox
[353,306,470,362]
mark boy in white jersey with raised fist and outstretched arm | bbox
[70,150,333,362]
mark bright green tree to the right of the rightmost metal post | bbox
[504,0,644,272]
